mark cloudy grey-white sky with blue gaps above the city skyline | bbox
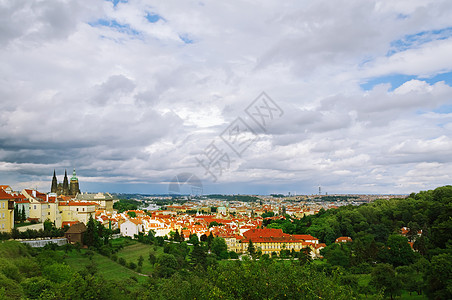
[0,0,452,194]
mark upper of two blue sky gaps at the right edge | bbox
[386,27,452,56]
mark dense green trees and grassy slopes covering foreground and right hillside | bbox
[0,186,452,299]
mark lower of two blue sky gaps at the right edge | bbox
[360,72,452,91]
